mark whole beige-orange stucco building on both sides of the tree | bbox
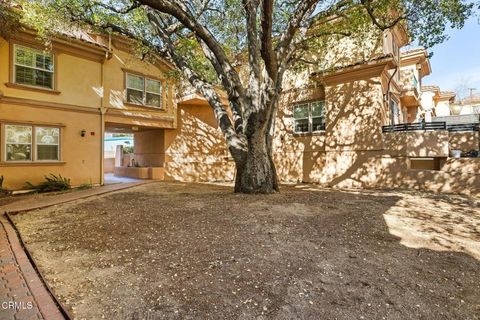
[0,23,480,193]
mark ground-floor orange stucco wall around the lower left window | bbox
[0,101,103,189]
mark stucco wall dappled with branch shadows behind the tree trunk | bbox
[165,77,480,193]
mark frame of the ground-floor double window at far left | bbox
[0,122,62,163]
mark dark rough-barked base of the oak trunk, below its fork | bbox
[235,135,279,194]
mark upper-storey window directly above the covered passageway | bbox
[126,73,162,108]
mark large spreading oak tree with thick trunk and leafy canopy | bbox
[11,0,474,193]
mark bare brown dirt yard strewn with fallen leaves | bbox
[8,183,480,320]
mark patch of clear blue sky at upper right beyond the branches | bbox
[423,17,480,95]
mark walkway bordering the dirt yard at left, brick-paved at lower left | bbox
[0,181,151,320]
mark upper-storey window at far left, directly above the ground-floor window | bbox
[14,45,54,89]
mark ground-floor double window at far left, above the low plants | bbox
[5,125,60,161]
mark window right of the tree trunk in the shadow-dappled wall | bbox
[293,101,325,133]
